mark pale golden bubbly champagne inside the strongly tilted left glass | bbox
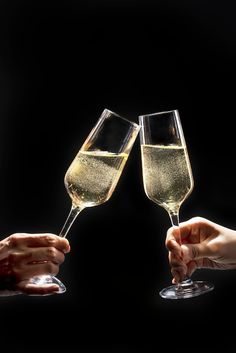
[65,151,128,208]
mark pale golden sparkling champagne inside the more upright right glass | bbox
[141,145,193,212]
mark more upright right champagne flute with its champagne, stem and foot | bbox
[139,110,214,299]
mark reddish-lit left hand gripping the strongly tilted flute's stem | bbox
[0,233,70,295]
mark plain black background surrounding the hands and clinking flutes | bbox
[0,0,236,353]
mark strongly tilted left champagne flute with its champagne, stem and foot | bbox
[31,109,140,293]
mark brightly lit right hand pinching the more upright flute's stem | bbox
[166,217,236,283]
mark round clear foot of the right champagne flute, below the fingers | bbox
[159,279,214,299]
